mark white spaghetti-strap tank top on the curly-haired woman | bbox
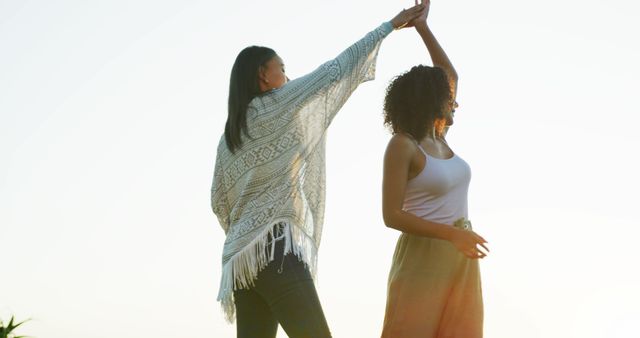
[403,142,471,224]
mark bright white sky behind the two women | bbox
[0,0,640,338]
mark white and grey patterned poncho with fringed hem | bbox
[211,22,393,321]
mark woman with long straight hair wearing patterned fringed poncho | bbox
[211,5,425,338]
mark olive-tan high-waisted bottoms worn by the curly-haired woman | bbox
[382,230,483,338]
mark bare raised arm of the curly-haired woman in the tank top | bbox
[411,0,458,99]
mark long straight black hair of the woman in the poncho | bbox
[224,46,276,153]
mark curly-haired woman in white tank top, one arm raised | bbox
[382,0,488,338]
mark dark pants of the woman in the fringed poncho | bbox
[233,226,331,338]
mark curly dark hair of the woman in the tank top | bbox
[384,65,452,141]
